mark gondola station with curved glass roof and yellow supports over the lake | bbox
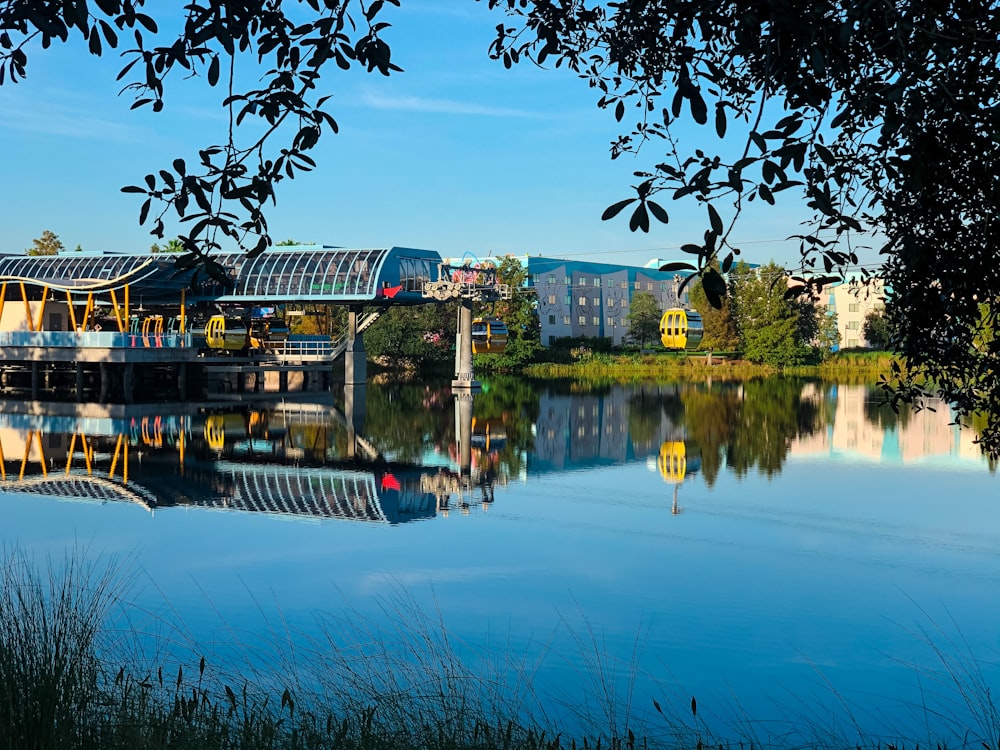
[0,246,509,403]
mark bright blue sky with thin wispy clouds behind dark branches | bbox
[0,0,864,264]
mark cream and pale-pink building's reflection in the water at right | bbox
[789,385,982,463]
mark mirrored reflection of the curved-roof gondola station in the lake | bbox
[0,402,504,524]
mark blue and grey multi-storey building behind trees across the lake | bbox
[519,256,690,346]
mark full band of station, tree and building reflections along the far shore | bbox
[0,379,985,524]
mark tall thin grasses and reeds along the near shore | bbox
[0,550,1000,750]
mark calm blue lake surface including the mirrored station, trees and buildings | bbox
[0,380,1000,738]
